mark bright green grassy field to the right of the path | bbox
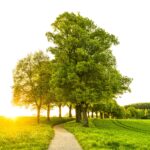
[65,119,150,150]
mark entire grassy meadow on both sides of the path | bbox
[0,117,150,150]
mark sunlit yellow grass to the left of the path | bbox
[0,117,72,150]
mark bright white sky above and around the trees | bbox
[0,0,150,114]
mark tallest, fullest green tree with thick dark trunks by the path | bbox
[46,12,131,126]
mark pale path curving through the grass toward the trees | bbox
[48,125,82,150]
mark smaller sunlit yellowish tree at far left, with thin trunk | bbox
[13,51,51,123]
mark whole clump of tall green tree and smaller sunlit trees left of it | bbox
[13,12,131,126]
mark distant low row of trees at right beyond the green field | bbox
[88,101,150,119]
